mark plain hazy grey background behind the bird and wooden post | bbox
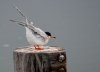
[0,0,100,72]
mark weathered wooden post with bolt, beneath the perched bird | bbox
[13,47,67,72]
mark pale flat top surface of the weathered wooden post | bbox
[14,46,65,53]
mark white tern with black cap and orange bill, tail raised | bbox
[10,7,56,50]
